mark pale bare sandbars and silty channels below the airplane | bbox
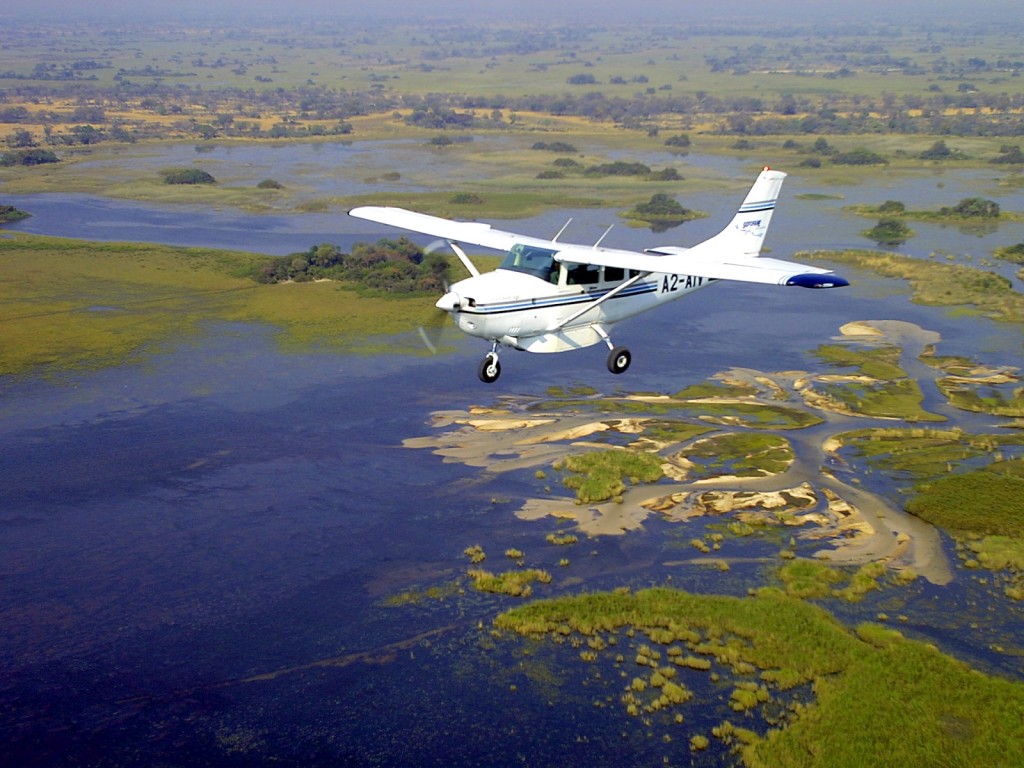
[404,321,952,585]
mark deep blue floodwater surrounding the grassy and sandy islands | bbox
[0,143,1024,766]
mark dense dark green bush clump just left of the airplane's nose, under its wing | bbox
[254,238,449,293]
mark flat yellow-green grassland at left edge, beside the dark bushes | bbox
[0,234,446,375]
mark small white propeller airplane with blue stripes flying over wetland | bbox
[348,167,849,384]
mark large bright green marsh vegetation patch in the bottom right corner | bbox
[495,589,1024,768]
